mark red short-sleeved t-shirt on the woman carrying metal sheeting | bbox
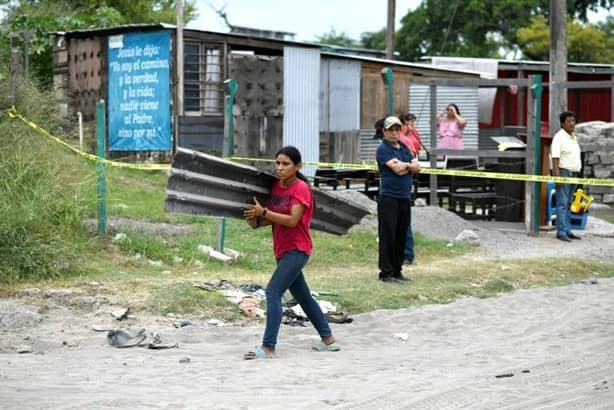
[268,179,313,259]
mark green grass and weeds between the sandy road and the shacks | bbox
[0,73,614,321]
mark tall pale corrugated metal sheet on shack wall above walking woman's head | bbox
[283,47,320,176]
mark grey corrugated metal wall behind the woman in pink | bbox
[409,84,478,149]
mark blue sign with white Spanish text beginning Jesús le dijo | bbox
[108,31,172,151]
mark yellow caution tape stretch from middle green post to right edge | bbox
[229,157,614,187]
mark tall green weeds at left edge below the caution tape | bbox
[0,76,87,283]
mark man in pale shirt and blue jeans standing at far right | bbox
[550,111,582,242]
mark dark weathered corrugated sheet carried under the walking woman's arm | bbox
[164,148,369,235]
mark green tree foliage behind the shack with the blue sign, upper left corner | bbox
[0,0,196,85]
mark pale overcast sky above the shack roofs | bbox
[187,0,420,41]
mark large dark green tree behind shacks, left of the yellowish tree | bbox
[395,0,614,61]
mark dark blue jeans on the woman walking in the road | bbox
[262,251,332,350]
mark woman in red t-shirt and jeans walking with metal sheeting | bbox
[243,146,339,359]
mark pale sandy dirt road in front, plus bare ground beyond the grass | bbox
[0,208,614,409]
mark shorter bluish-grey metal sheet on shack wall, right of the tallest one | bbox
[320,58,360,132]
